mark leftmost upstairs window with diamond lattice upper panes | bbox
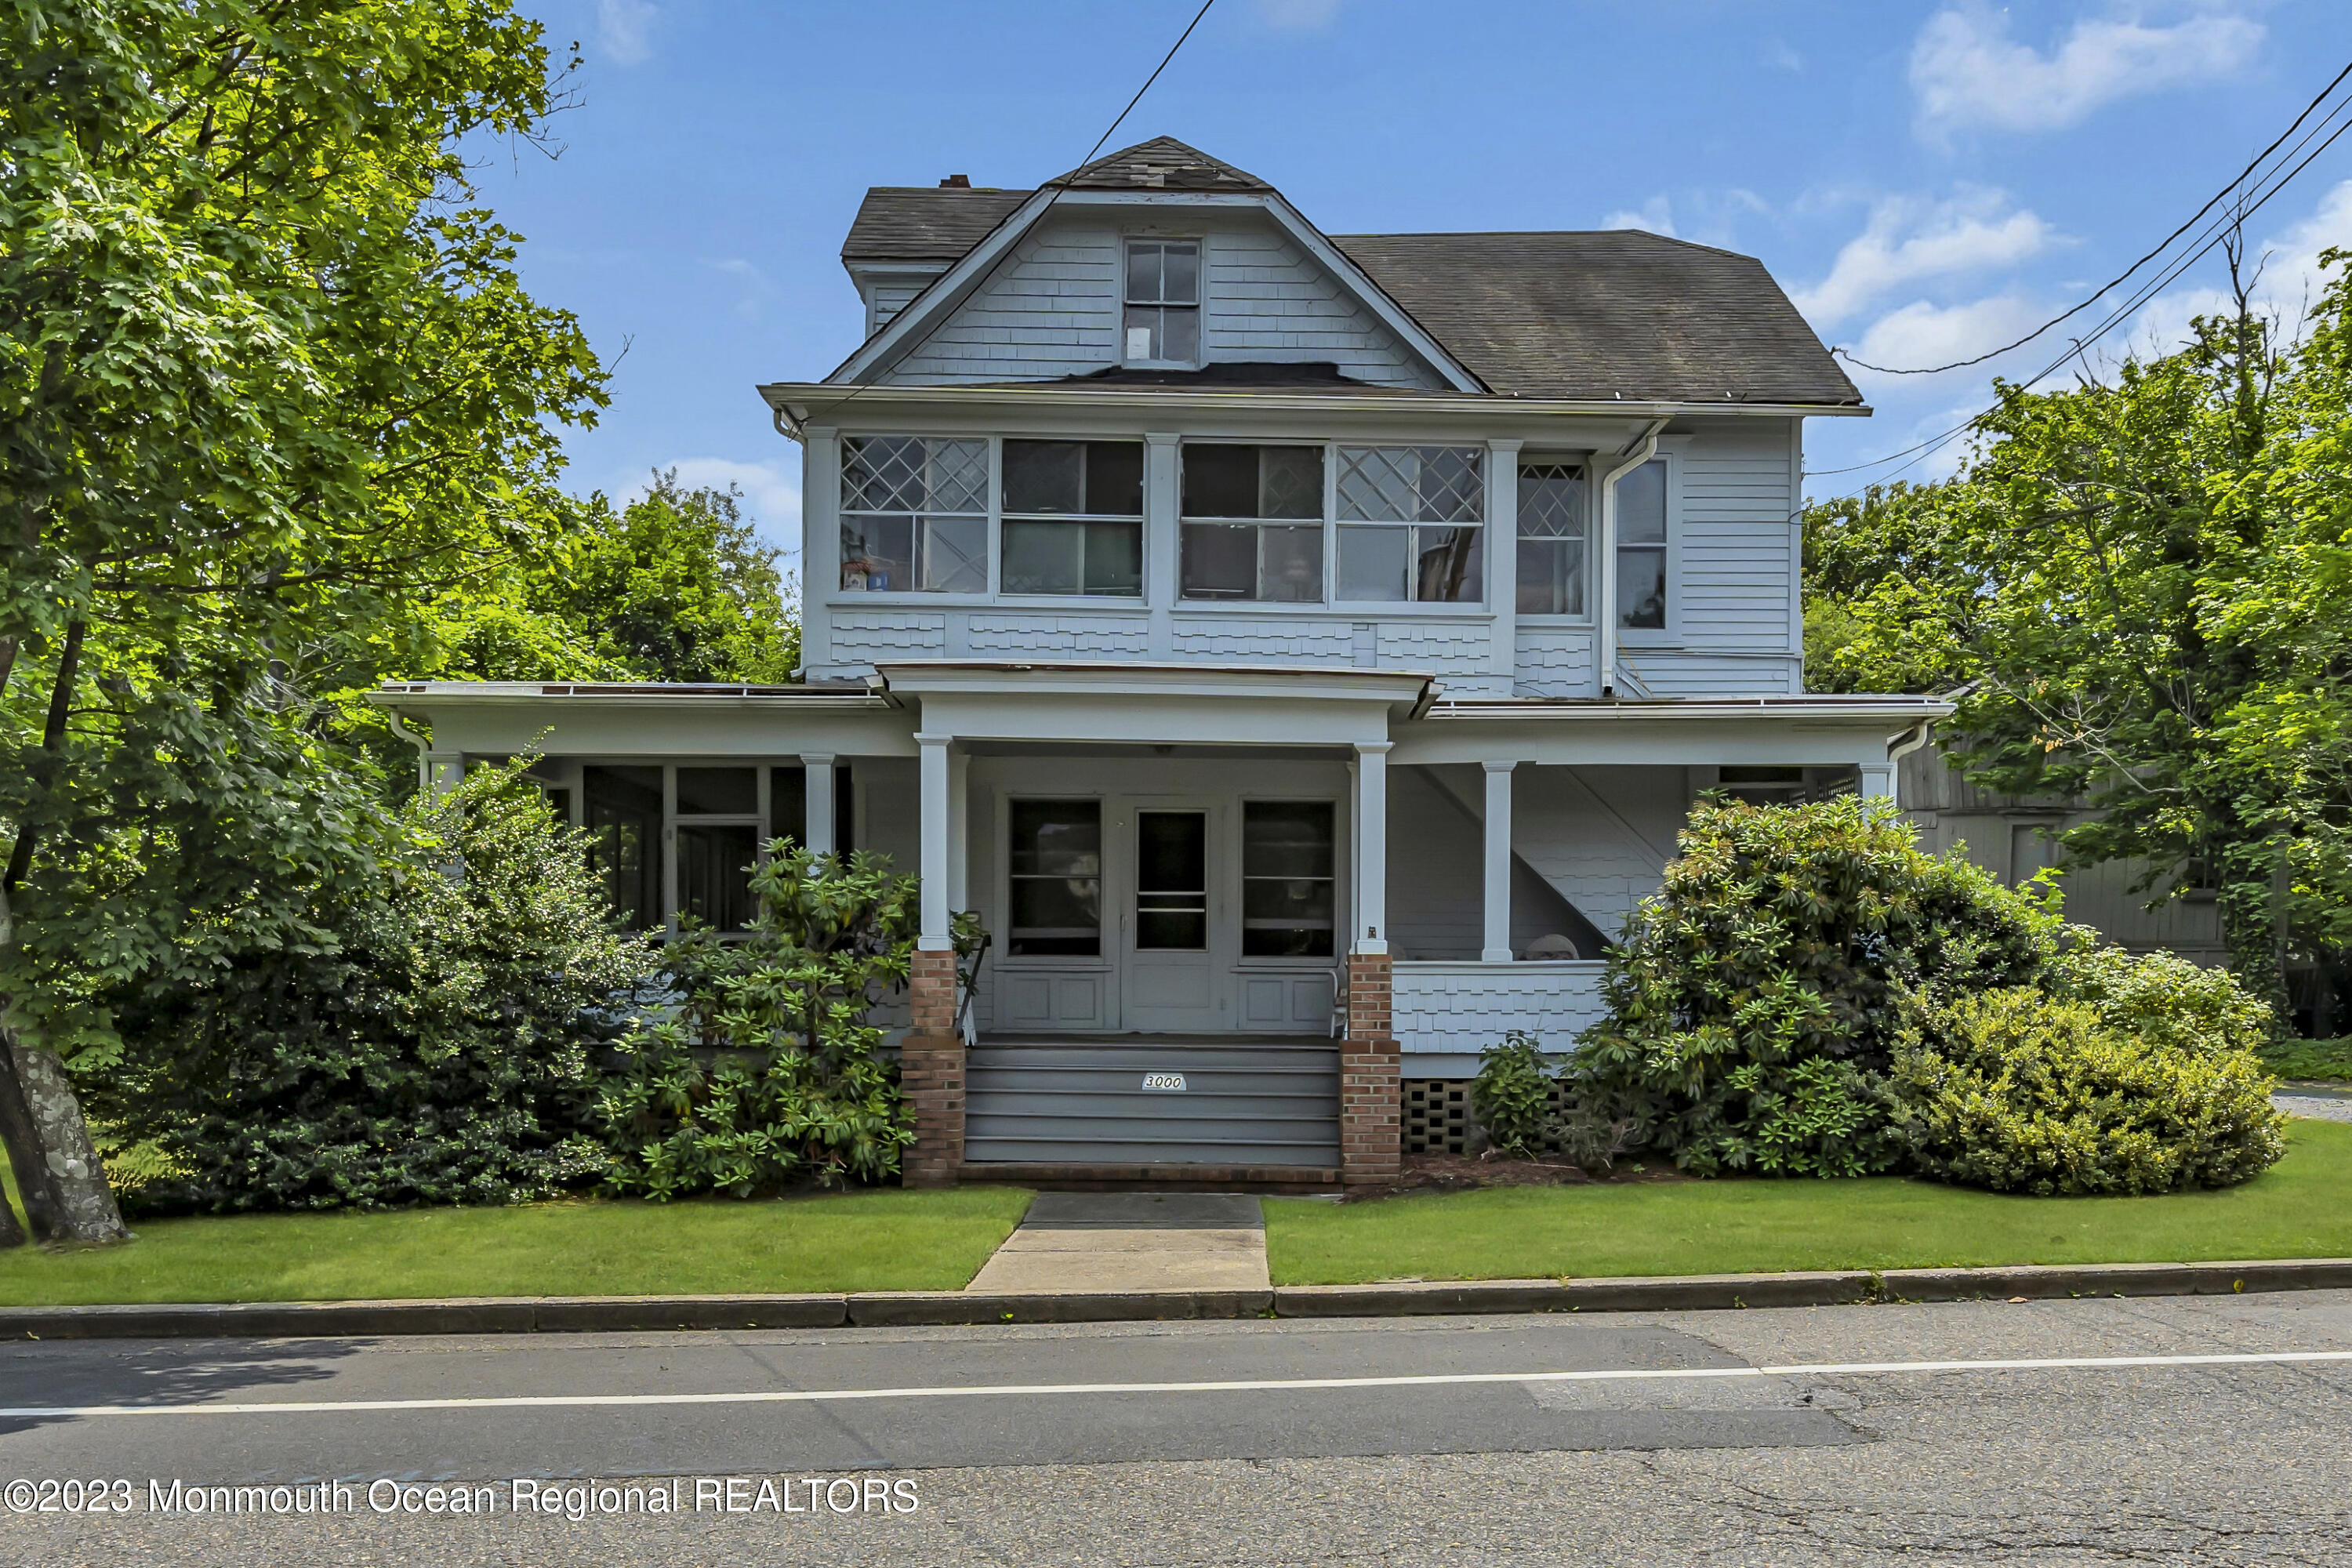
[842,435,988,593]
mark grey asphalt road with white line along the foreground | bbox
[0,1293,2352,1568]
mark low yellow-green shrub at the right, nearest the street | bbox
[1889,987,2286,1196]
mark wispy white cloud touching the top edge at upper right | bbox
[1910,0,2263,139]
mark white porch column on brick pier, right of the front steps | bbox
[1338,741,1404,1185]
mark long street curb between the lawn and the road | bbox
[0,1258,2352,1340]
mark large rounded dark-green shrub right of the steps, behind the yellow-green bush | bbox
[1571,797,2070,1175]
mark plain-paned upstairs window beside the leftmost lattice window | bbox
[1002,440,1143,597]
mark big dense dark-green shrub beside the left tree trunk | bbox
[92,764,654,1213]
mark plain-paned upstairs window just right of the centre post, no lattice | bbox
[1178,453,1324,604]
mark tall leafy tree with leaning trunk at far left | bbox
[0,0,604,1239]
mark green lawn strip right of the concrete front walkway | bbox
[1265,1119,2352,1286]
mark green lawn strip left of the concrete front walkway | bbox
[0,1185,1030,1307]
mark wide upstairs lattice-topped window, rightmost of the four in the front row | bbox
[1336,447,1486,604]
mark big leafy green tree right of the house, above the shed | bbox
[1806,254,2352,1020]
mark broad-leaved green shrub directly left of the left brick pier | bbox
[597,841,920,1201]
